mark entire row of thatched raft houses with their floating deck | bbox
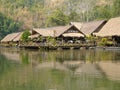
[1,17,120,49]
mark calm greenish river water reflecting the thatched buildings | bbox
[0,48,120,90]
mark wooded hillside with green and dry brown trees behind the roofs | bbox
[0,0,120,39]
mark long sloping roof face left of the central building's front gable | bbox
[33,25,75,37]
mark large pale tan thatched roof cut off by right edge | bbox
[96,17,120,37]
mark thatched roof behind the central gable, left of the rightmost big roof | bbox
[71,20,106,35]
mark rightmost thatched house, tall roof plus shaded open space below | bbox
[93,17,120,47]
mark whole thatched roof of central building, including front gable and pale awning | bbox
[31,25,84,37]
